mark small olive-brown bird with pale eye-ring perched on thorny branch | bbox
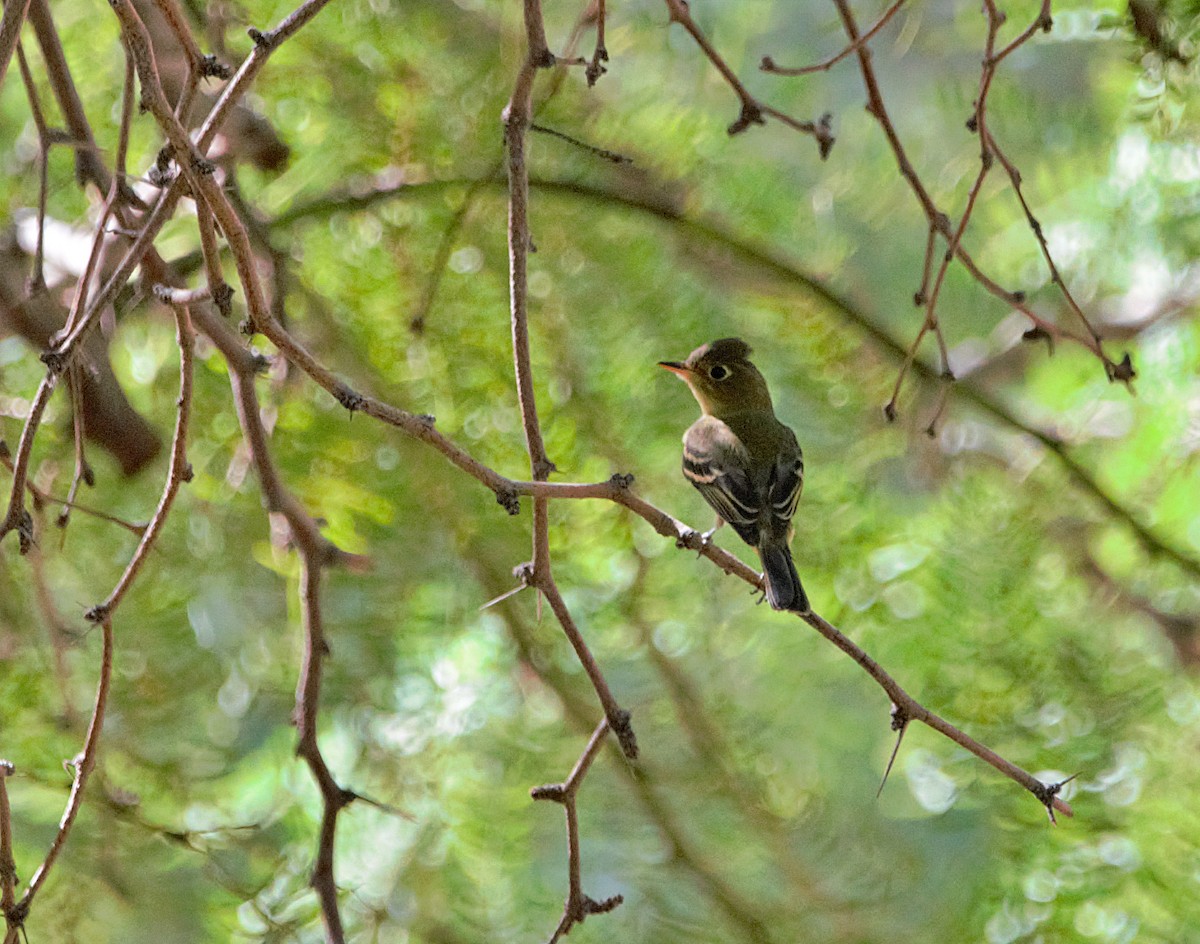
[659,337,809,613]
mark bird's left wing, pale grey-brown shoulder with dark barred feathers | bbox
[683,417,762,545]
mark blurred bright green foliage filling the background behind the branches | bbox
[0,0,1200,944]
